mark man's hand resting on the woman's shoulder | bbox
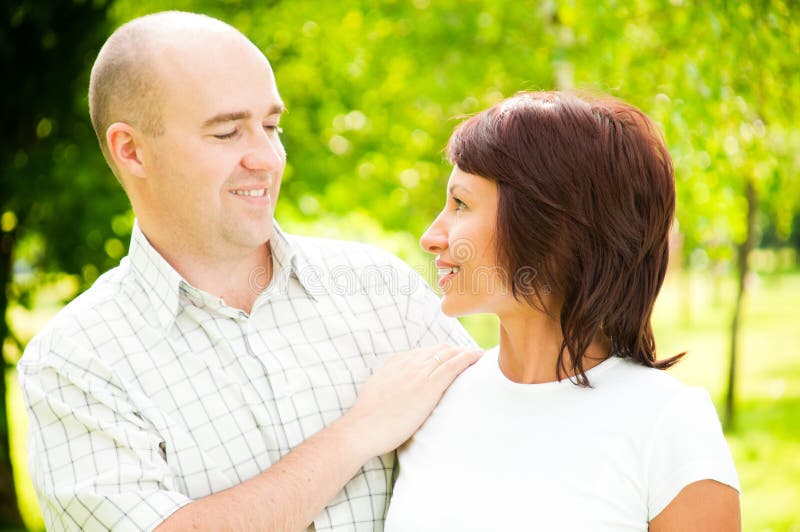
[339,345,482,457]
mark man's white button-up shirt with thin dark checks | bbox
[18,218,472,531]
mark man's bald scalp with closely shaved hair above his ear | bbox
[89,11,255,177]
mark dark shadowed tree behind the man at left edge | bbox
[0,0,119,528]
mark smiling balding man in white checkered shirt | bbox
[19,12,479,530]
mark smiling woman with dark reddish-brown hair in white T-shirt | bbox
[386,92,740,532]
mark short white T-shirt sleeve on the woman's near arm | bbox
[646,387,741,520]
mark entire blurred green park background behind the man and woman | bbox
[0,0,800,531]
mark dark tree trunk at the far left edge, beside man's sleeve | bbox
[0,225,25,529]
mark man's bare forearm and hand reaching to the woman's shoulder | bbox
[158,345,480,531]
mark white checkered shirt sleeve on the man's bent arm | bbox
[18,332,191,530]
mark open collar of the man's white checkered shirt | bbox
[128,220,316,328]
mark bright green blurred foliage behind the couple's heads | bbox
[104,0,800,262]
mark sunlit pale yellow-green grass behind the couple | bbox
[7,272,800,532]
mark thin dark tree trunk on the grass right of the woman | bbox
[724,179,758,430]
